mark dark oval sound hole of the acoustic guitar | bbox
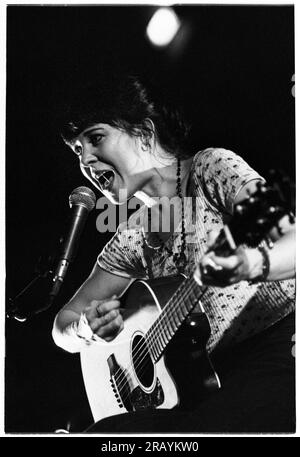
[132,335,154,388]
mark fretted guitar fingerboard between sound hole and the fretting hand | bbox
[145,275,207,362]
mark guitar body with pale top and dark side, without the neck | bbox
[81,277,220,422]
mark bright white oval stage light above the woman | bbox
[146,8,180,47]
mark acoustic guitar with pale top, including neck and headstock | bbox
[80,175,294,422]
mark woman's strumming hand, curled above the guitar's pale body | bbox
[85,295,124,342]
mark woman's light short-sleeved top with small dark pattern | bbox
[98,148,295,351]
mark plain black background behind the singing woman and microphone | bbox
[5,5,295,433]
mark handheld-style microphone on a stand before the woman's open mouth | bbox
[48,186,96,306]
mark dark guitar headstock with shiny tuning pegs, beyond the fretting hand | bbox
[229,170,295,247]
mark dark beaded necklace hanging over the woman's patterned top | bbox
[143,159,187,277]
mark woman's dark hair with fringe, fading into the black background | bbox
[61,76,193,158]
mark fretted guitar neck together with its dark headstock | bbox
[146,174,291,361]
